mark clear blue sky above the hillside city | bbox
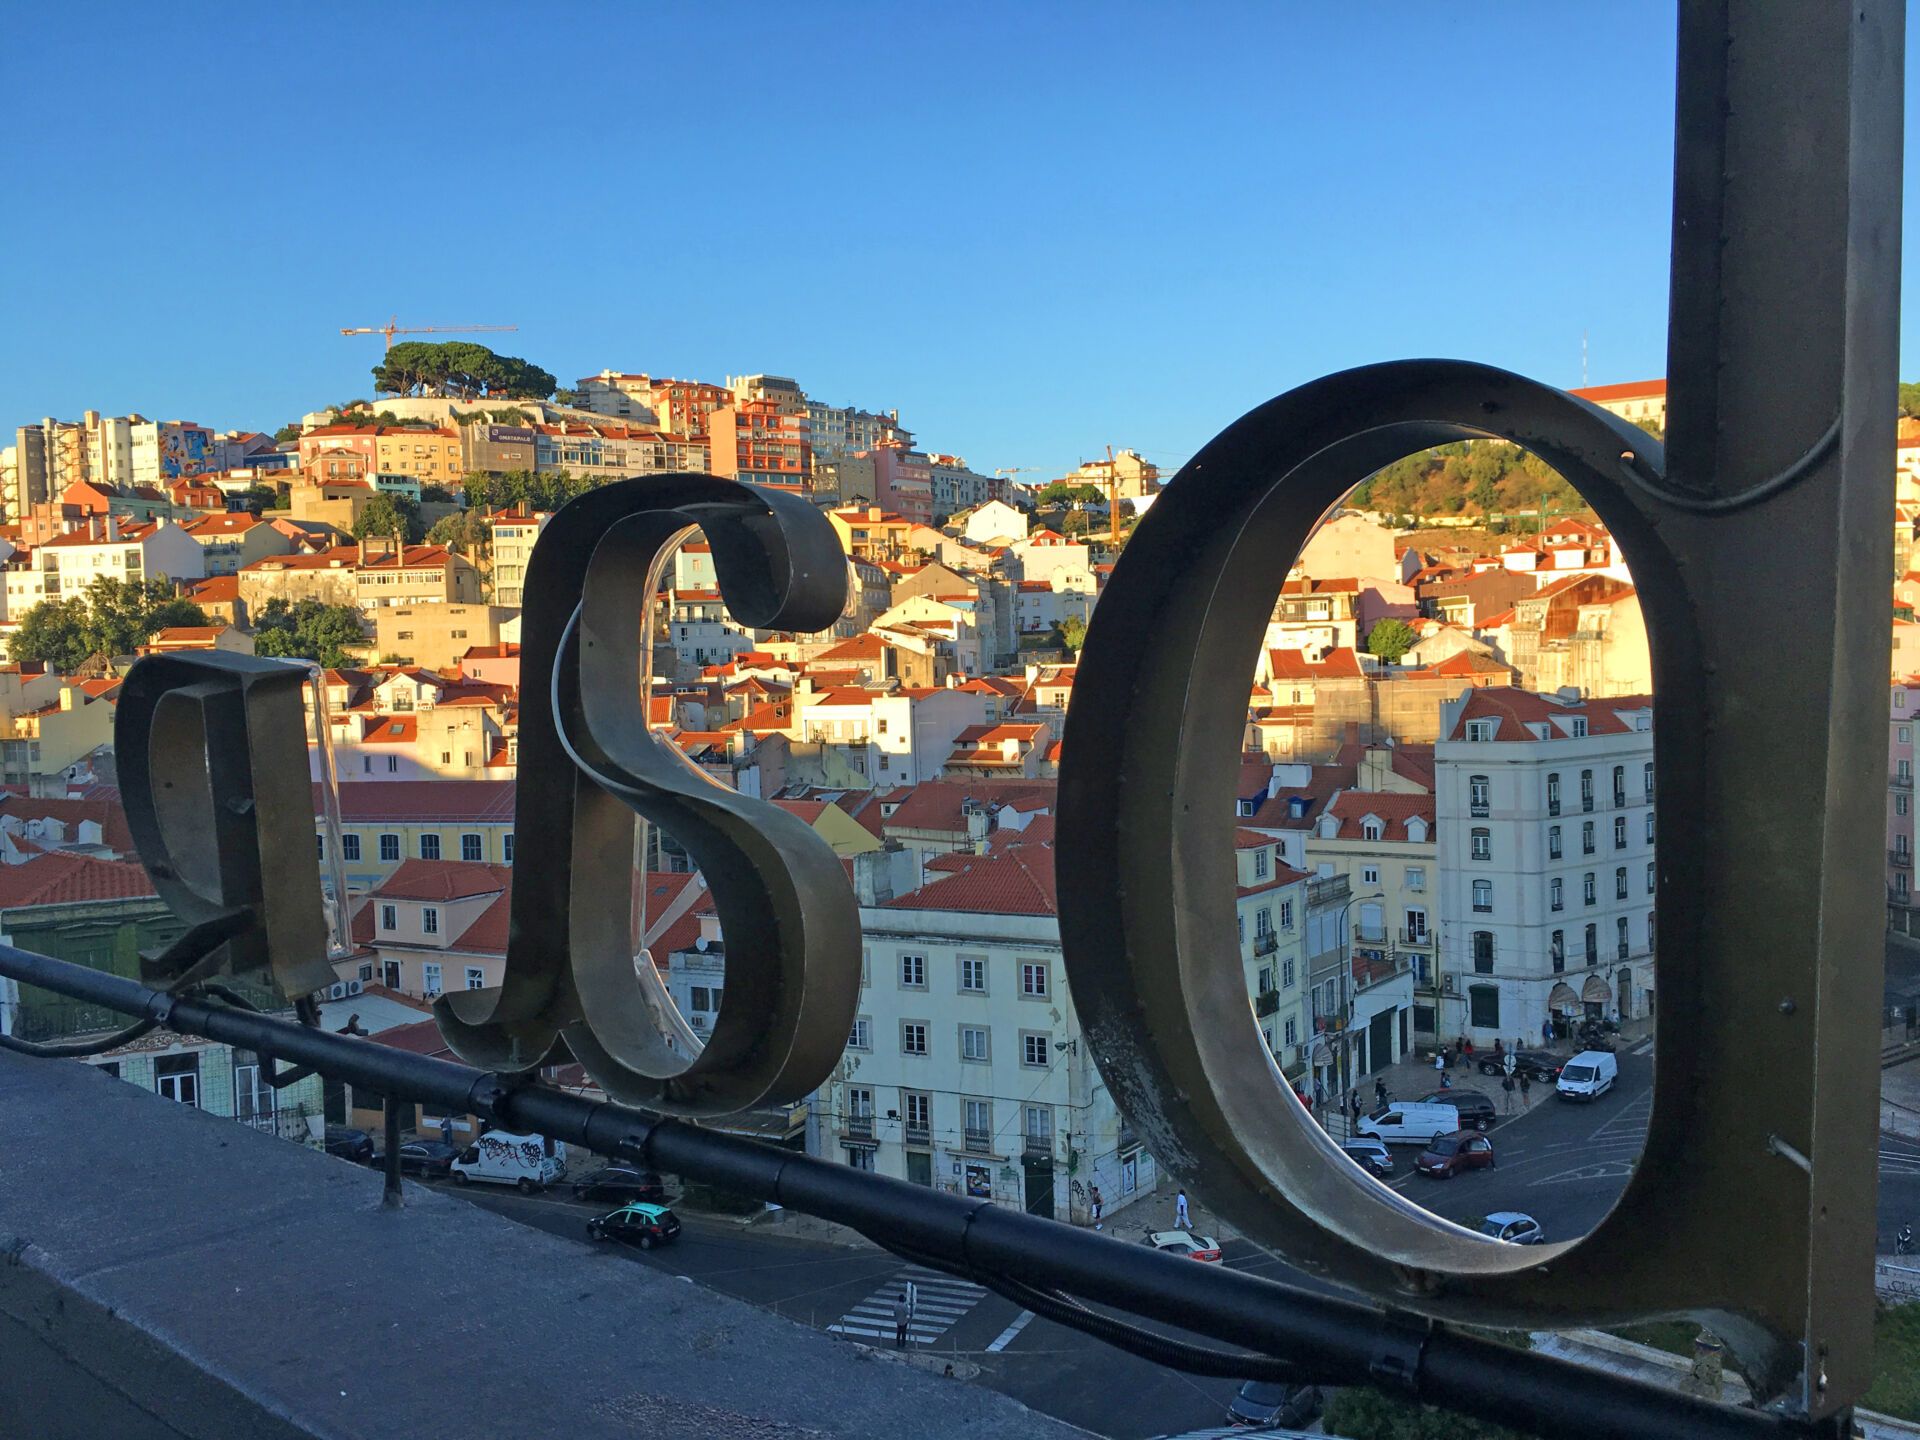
[0,0,1920,480]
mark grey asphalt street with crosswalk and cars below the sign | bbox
[385,1043,1920,1440]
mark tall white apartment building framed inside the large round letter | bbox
[1434,689,1655,1046]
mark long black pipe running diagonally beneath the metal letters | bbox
[0,947,1830,1440]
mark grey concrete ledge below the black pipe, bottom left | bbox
[0,1052,1083,1440]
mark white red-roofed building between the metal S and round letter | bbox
[816,845,1154,1223]
